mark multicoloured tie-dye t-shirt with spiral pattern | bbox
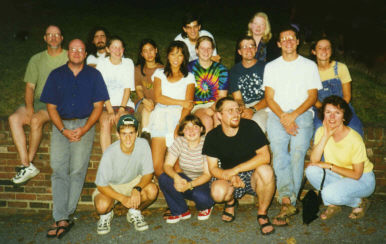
[188,59,229,104]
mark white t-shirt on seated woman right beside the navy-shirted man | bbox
[96,57,135,108]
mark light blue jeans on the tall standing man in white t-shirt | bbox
[267,111,313,205]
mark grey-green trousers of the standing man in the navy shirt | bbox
[50,118,95,221]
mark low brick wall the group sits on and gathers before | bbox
[0,117,386,214]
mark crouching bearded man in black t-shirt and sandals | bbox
[202,97,275,235]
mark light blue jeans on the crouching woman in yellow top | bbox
[306,166,375,208]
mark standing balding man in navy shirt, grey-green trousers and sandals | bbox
[40,39,109,238]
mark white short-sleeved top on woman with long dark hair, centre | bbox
[151,68,196,100]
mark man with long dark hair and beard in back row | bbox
[86,26,109,68]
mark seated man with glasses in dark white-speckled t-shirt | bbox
[229,36,267,133]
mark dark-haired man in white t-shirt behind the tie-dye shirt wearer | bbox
[174,13,221,63]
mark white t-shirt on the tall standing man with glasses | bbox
[263,55,322,111]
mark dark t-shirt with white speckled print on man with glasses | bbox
[229,62,265,104]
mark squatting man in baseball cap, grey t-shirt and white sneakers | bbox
[93,114,158,235]
